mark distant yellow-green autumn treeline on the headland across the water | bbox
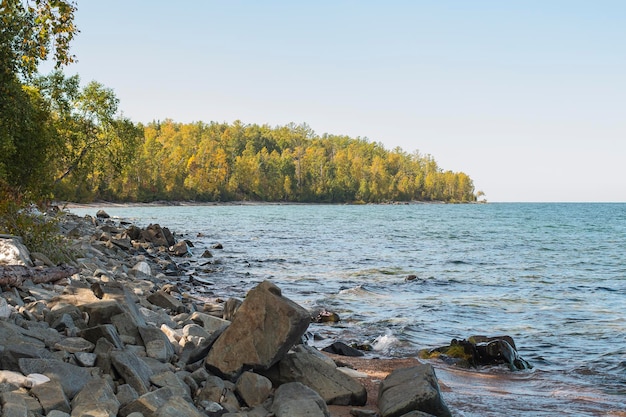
[78,120,476,203]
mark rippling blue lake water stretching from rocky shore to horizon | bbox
[71,203,626,416]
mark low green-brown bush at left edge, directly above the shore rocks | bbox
[0,187,74,264]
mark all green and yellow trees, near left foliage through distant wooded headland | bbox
[0,0,480,203]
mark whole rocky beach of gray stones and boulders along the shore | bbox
[0,208,451,417]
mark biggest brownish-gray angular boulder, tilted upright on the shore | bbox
[205,281,311,379]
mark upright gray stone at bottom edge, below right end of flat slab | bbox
[72,378,120,417]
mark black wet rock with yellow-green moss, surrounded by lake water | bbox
[420,336,532,371]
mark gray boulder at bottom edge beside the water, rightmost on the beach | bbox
[378,364,452,417]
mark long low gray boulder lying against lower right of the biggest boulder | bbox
[267,349,367,405]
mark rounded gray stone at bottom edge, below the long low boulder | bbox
[271,382,330,417]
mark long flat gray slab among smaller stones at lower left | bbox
[19,358,92,399]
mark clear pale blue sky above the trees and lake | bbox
[56,0,626,201]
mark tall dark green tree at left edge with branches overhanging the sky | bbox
[0,0,78,194]
